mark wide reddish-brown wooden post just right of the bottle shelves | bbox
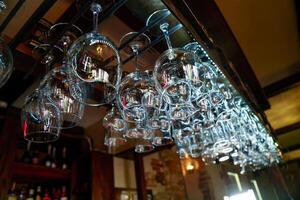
[91,151,114,200]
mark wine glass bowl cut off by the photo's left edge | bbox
[0,39,13,88]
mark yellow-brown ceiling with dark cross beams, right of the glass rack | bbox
[215,0,300,160]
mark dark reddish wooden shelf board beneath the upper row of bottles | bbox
[12,162,71,180]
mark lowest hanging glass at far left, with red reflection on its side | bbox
[21,90,62,143]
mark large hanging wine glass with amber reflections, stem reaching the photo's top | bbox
[68,3,122,106]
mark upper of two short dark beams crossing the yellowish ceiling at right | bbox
[264,72,300,98]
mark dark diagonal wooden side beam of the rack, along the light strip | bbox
[163,0,270,110]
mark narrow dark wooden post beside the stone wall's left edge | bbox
[134,153,147,200]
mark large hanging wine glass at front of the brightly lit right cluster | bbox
[146,9,197,105]
